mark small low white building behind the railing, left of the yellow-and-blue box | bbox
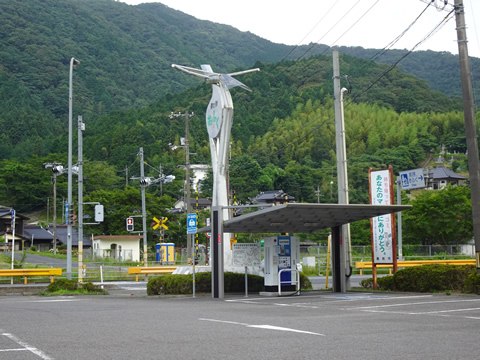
[92,235,142,261]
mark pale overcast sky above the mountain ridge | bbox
[120,0,480,57]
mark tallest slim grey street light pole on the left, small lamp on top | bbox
[67,57,80,280]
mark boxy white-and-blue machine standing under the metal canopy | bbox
[264,235,300,292]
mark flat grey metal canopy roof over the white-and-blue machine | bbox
[197,203,411,233]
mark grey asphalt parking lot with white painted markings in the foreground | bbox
[0,289,480,360]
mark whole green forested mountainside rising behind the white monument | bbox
[0,0,480,243]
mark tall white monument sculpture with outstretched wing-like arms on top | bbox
[172,64,260,266]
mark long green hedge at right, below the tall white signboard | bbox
[360,264,480,294]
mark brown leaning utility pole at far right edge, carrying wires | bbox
[454,0,480,274]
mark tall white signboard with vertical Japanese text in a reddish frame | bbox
[370,170,394,264]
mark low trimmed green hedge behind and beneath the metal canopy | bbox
[147,272,312,295]
